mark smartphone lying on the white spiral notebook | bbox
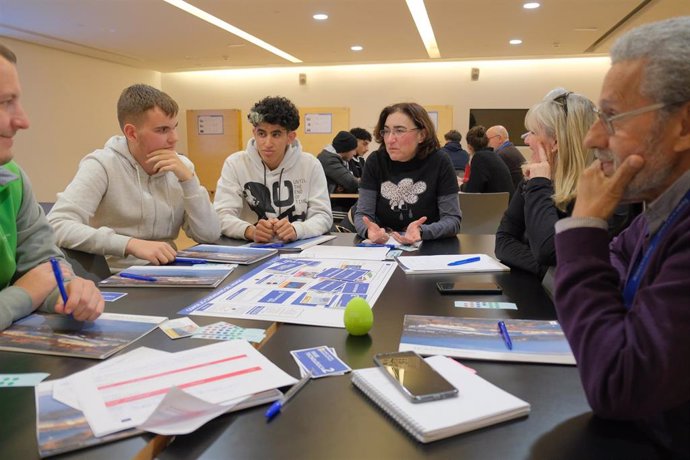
[374,351,458,403]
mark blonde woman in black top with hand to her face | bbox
[492,88,596,277]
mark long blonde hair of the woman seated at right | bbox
[525,89,596,211]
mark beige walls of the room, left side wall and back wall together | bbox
[1,39,608,201]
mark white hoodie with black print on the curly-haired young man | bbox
[213,138,333,239]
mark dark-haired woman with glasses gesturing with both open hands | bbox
[355,102,460,244]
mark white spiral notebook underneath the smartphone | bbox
[352,356,530,443]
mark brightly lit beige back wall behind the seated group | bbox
[162,57,609,161]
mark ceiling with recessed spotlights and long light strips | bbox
[0,0,690,72]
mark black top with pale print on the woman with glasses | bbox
[355,148,460,240]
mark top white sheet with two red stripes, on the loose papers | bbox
[74,340,296,436]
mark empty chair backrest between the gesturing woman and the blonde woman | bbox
[458,192,508,235]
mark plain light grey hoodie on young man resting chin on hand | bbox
[48,136,220,268]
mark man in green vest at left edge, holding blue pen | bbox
[0,44,104,330]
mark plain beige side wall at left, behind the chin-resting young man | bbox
[5,38,161,201]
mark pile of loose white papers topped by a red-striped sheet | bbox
[38,340,296,438]
